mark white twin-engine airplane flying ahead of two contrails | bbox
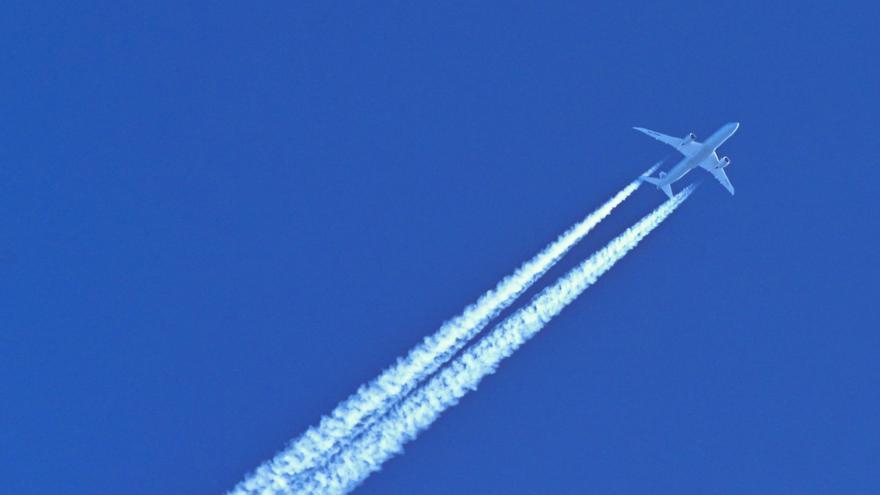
[633,122,739,198]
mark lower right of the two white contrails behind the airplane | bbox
[293,185,696,494]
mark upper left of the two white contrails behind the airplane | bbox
[230,163,660,495]
